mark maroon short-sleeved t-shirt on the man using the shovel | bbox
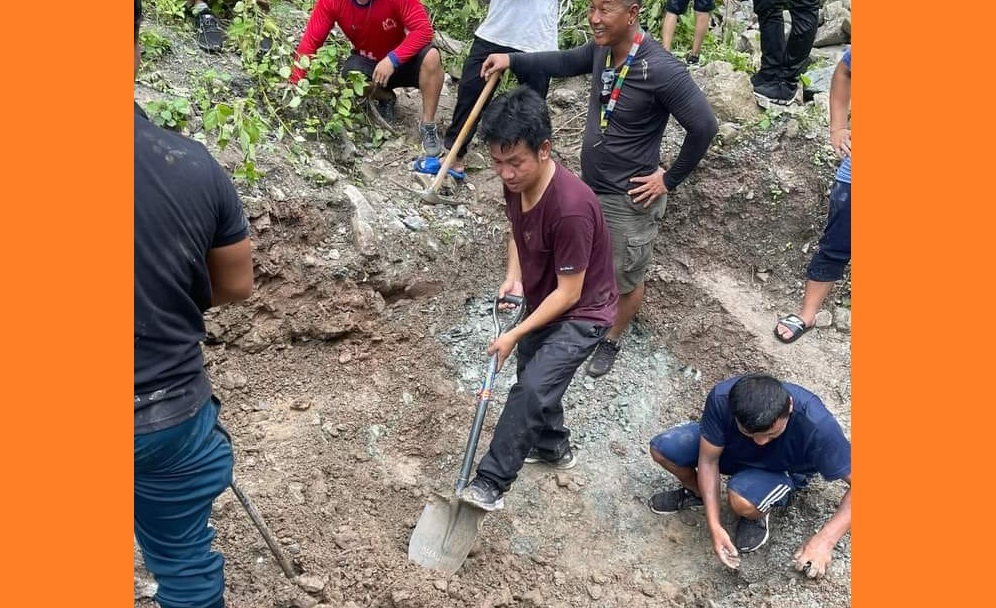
[504,161,619,325]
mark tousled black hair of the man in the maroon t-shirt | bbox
[481,86,553,152]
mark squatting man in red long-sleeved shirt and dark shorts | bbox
[290,0,443,156]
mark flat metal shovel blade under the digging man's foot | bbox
[408,493,487,574]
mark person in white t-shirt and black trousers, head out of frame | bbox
[443,0,560,175]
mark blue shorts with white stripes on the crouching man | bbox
[650,422,809,513]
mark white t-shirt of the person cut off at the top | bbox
[474,0,560,52]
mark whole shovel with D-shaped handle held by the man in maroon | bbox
[408,296,525,574]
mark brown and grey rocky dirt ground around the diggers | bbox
[135,2,851,608]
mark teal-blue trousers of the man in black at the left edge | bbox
[135,397,233,608]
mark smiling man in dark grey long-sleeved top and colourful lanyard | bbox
[481,0,718,377]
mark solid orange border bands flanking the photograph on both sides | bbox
[0,0,984,607]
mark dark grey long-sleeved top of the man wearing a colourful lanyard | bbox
[510,36,718,195]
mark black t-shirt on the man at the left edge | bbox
[135,103,249,434]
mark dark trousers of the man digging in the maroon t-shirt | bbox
[477,321,608,491]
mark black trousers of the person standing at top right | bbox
[754,0,820,87]
